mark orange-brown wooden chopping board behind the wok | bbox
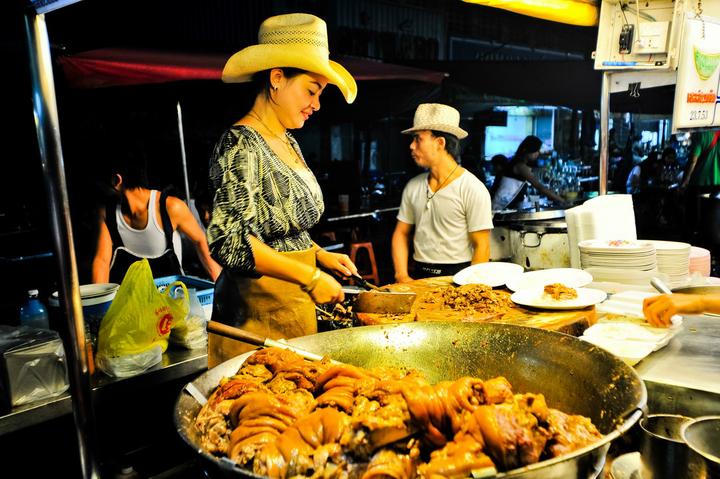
[356,276,597,336]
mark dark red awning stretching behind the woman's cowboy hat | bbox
[58,48,447,88]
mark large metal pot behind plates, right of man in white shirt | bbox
[509,221,570,270]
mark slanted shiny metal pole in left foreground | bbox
[25,10,100,479]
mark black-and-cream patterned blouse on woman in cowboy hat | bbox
[207,125,325,275]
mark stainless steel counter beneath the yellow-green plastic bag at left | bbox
[0,348,207,435]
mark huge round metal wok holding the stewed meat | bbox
[175,322,647,479]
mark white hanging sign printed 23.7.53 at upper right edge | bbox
[673,17,720,130]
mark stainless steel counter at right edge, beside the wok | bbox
[635,316,720,416]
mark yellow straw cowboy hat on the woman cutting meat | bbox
[222,13,357,103]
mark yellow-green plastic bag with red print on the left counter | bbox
[96,259,189,376]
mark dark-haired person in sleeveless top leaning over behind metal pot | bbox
[492,135,567,210]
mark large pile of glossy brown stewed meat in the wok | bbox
[195,348,602,479]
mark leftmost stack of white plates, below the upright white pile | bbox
[578,239,658,284]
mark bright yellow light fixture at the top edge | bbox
[462,0,599,27]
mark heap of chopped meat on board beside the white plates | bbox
[425,284,513,314]
